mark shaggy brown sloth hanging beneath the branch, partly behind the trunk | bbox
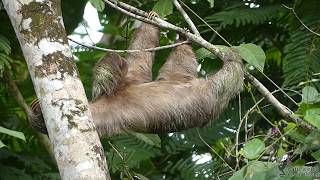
[32,14,243,136]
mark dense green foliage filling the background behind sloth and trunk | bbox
[0,0,320,180]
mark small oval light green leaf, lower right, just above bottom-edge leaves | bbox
[240,139,265,159]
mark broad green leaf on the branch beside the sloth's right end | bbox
[235,43,266,71]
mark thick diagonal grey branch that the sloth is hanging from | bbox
[104,0,313,129]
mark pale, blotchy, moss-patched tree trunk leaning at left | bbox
[2,0,110,179]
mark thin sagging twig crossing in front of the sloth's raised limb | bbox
[68,38,190,53]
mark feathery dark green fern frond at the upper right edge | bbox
[283,19,320,88]
